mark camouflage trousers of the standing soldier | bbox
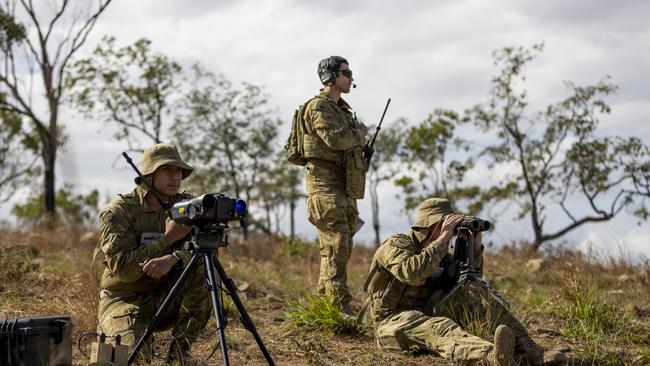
[307,193,359,308]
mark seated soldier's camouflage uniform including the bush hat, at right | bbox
[366,199,528,362]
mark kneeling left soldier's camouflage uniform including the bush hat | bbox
[94,144,211,359]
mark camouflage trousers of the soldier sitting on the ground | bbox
[375,283,528,363]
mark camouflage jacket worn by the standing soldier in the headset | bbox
[303,92,366,167]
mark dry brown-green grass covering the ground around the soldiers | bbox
[0,229,650,365]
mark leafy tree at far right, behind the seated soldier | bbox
[470,45,650,249]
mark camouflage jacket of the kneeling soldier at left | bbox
[93,186,191,293]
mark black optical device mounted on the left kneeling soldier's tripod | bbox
[171,193,246,225]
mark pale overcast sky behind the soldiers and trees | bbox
[5,0,650,255]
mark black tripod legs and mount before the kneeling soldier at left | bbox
[128,224,275,366]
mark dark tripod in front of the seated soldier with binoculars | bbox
[432,227,509,312]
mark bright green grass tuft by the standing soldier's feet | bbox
[287,296,360,334]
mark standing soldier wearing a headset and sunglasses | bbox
[302,56,368,315]
